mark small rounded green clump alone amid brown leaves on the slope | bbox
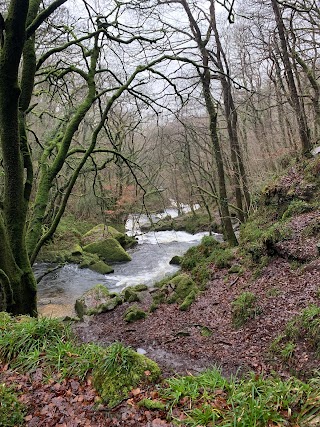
[232,292,260,328]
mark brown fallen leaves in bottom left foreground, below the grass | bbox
[0,365,172,427]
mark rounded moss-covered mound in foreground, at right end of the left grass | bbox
[93,343,161,408]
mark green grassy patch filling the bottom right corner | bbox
[160,369,320,427]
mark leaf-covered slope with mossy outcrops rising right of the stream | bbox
[76,157,320,376]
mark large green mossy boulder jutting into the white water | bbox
[83,238,131,262]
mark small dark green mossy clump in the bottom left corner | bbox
[0,384,24,427]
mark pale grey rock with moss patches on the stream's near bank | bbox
[75,285,122,319]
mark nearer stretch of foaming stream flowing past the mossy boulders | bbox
[34,211,222,317]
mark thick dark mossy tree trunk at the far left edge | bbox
[0,0,37,315]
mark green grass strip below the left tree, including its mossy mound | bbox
[0,313,160,408]
